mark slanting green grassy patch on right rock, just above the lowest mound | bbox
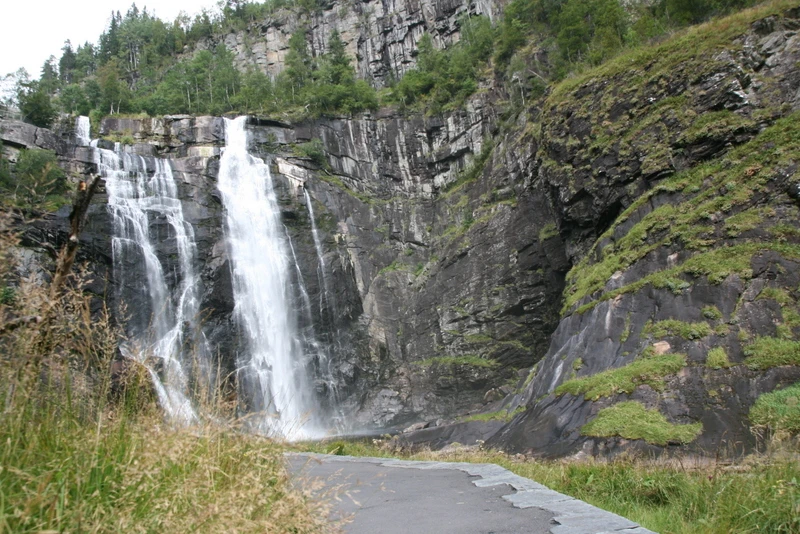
[555,354,686,400]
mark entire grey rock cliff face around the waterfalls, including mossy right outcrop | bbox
[2,2,800,456]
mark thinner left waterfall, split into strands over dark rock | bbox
[93,143,207,424]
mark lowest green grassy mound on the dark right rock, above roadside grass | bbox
[581,401,703,446]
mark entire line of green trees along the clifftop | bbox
[6,0,755,127]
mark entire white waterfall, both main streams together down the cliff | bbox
[89,117,345,440]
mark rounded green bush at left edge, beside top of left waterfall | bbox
[0,149,69,210]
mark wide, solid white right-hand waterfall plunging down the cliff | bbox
[218,117,322,439]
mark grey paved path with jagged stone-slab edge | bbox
[287,454,653,534]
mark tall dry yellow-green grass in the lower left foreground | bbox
[0,217,329,532]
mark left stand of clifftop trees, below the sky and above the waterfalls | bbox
[20,0,378,125]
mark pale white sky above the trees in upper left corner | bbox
[0,0,216,78]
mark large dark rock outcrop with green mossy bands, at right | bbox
[489,6,800,456]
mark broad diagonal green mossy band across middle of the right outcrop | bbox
[563,113,800,313]
